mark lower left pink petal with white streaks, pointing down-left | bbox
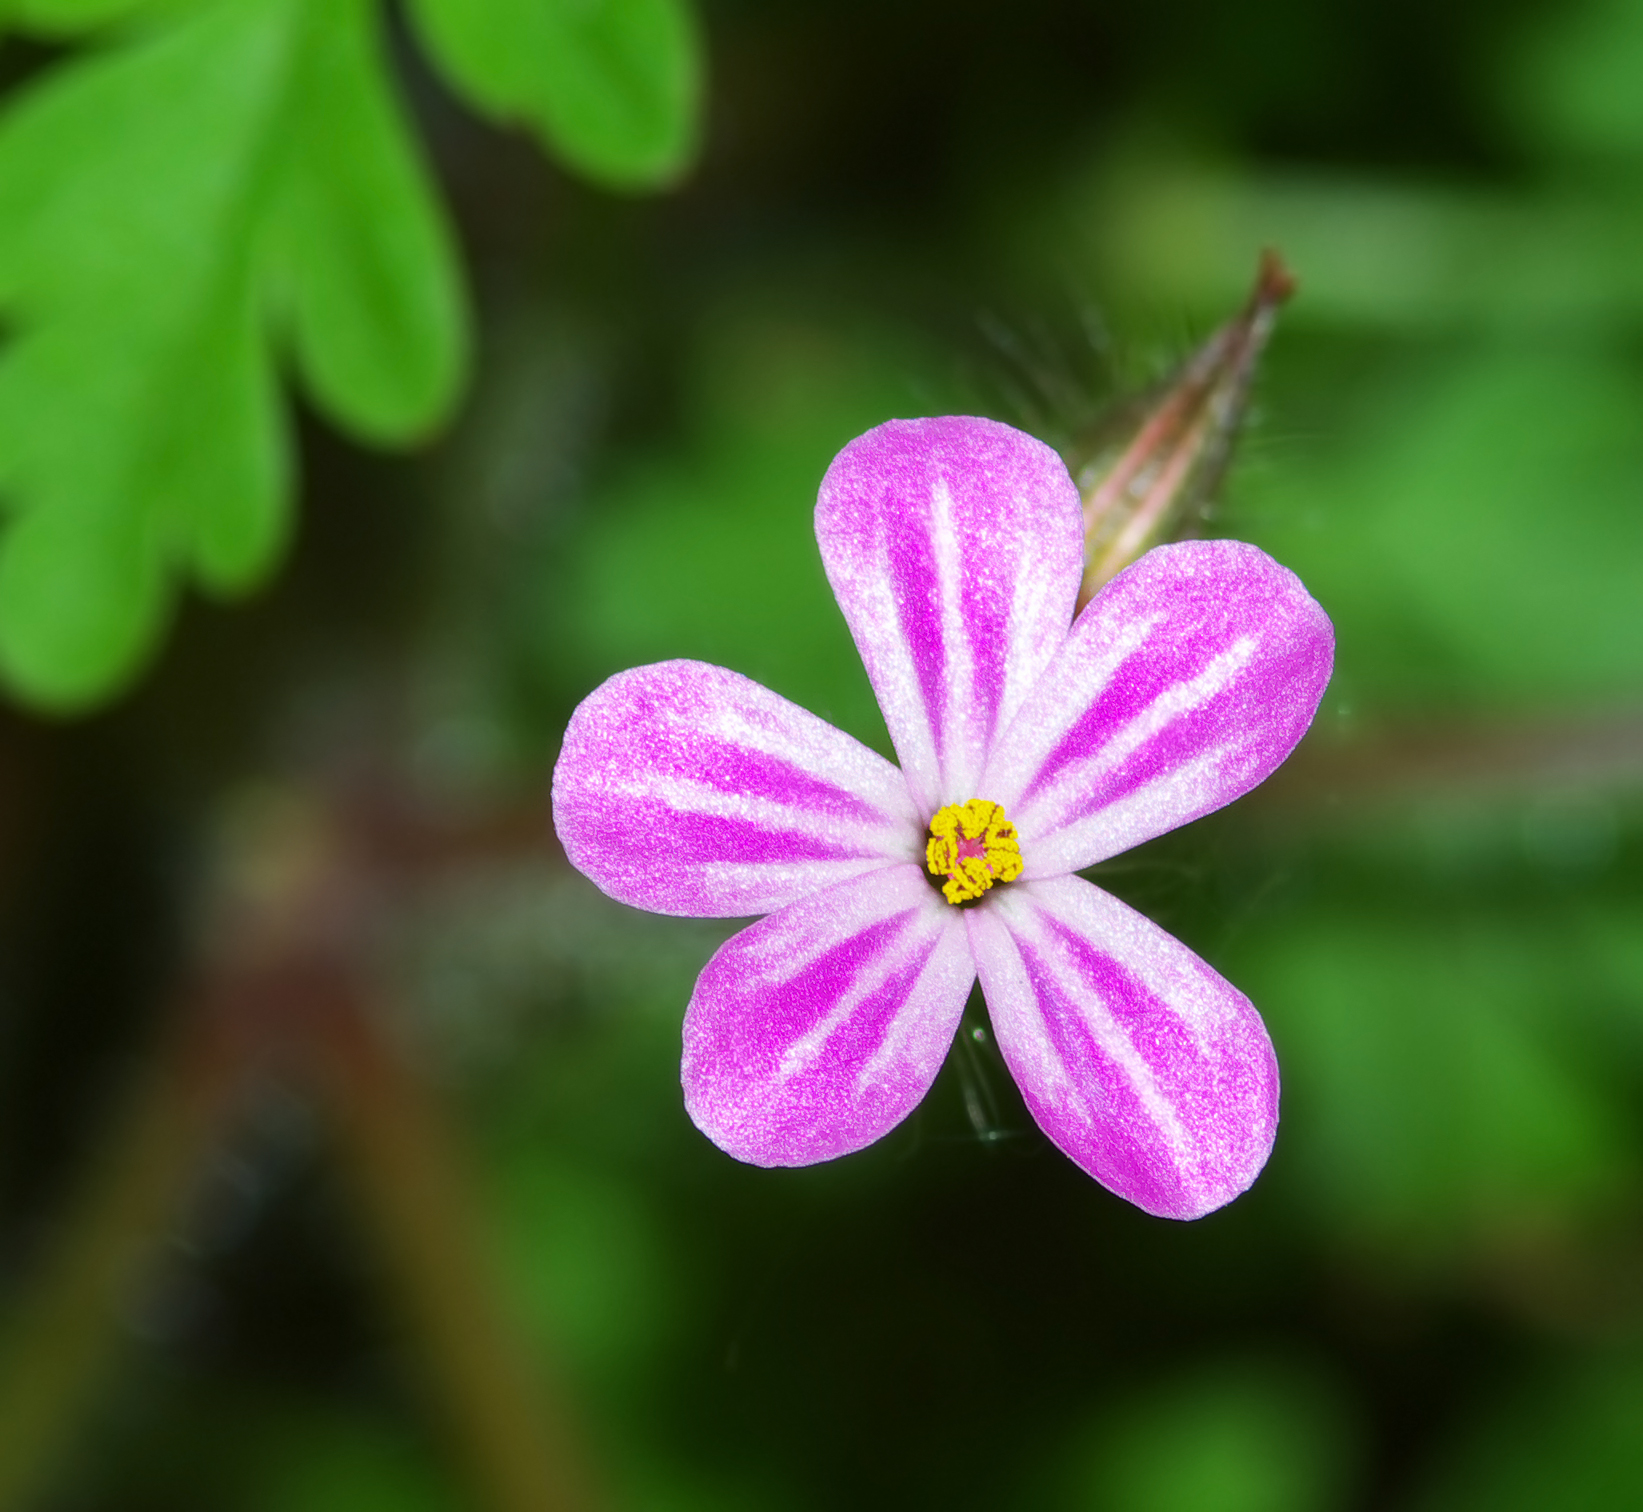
[682,866,976,1165]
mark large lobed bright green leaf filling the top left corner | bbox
[0,0,463,708]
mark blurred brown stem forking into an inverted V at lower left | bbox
[0,791,596,1512]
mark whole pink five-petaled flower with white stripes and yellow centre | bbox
[554,419,1334,1218]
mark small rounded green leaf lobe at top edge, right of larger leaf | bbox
[411,0,702,189]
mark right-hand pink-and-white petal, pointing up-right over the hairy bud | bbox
[981,541,1334,879]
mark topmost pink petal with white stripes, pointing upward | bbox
[817,416,1083,817]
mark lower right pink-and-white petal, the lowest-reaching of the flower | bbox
[968,876,1278,1218]
